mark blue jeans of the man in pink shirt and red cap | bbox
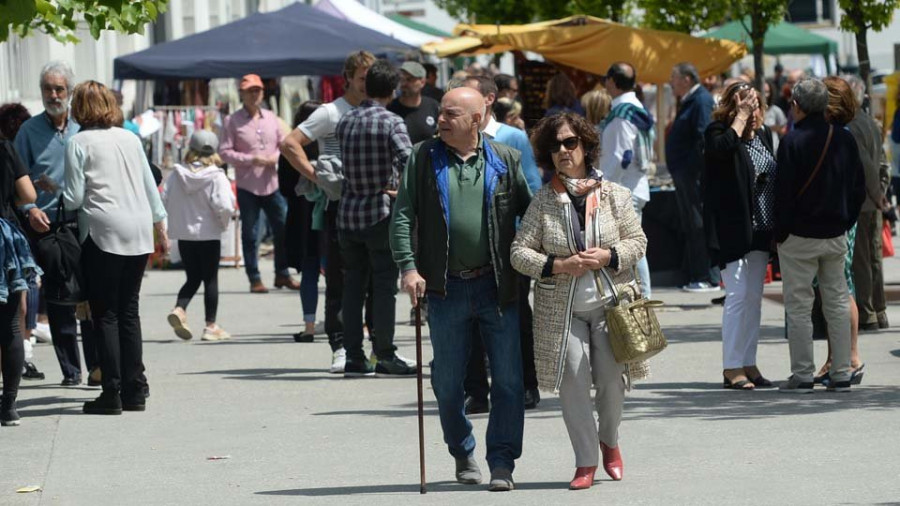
[238,188,290,282]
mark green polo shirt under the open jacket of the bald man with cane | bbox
[447,144,491,271]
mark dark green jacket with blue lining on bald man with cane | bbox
[391,139,531,307]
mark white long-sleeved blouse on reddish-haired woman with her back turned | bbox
[63,127,166,256]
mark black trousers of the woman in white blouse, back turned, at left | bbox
[81,237,149,401]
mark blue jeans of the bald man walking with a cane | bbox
[428,274,525,471]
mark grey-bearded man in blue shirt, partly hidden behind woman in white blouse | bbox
[15,61,96,386]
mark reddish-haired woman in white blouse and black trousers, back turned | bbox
[63,81,168,415]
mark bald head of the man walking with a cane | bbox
[438,87,485,151]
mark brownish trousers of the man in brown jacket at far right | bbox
[853,210,886,325]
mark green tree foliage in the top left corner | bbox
[0,0,169,42]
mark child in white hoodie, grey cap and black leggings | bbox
[162,130,235,341]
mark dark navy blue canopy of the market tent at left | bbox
[113,3,415,79]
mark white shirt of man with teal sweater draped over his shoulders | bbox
[599,91,650,202]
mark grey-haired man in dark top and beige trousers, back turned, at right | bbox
[775,79,866,393]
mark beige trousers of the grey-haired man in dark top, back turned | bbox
[778,235,850,382]
